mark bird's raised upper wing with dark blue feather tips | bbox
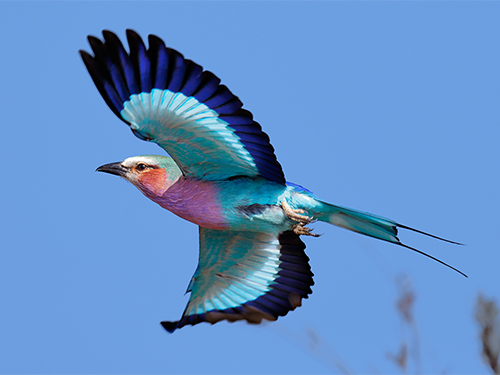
[80,30,285,184]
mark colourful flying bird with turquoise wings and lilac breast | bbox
[79,29,467,333]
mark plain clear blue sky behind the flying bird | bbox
[0,1,500,374]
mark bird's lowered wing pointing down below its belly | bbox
[161,227,314,332]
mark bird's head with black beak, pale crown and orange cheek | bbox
[96,155,182,197]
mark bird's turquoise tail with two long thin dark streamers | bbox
[314,200,467,277]
